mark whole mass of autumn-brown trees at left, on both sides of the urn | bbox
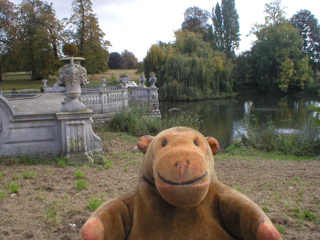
[0,0,114,79]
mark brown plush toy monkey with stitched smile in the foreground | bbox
[81,127,281,240]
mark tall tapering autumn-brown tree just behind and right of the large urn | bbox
[68,0,110,73]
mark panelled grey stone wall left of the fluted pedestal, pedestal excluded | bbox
[0,95,62,158]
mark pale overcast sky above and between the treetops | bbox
[11,0,320,61]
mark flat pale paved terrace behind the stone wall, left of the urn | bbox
[9,93,65,115]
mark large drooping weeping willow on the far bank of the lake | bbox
[144,31,232,101]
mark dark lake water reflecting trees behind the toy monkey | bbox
[160,95,320,148]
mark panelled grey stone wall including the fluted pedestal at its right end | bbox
[0,95,102,163]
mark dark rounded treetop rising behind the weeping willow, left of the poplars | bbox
[181,7,210,41]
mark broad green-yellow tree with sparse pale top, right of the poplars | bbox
[251,1,313,93]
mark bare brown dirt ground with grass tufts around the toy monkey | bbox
[0,134,320,240]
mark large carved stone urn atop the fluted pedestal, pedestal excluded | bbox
[57,57,89,112]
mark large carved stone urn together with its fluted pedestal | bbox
[56,57,102,164]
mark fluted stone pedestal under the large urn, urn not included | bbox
[56,110,102,164]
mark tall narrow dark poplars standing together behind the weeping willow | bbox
[212,0,240,58]
